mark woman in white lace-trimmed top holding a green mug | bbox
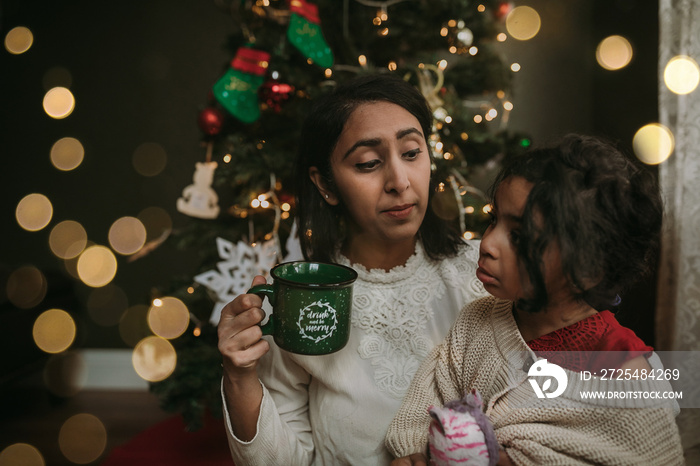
[219,76,485,466]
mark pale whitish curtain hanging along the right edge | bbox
[656,0,700,464]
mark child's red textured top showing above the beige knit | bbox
[527,311,654,373]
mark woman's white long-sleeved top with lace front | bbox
[224,242,486,466]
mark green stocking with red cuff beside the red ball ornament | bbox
[213,47,270,123]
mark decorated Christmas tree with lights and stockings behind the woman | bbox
[151,0,530,429]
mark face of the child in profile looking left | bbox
[476,176,570,304]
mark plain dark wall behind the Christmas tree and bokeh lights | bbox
[0,0,658,351]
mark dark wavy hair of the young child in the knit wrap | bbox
[491,135,663,311]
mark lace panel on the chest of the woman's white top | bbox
[341,243,473,399]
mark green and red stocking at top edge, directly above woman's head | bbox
[287,0,333,68]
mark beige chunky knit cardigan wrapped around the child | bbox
[386,297,683,465]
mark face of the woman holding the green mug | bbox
[322,102,430,248]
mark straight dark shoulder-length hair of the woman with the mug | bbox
[294,74,461,262]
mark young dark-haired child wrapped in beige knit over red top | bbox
[386,135,683,465]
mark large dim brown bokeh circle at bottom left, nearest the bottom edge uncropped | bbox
[58,413,107,464]
